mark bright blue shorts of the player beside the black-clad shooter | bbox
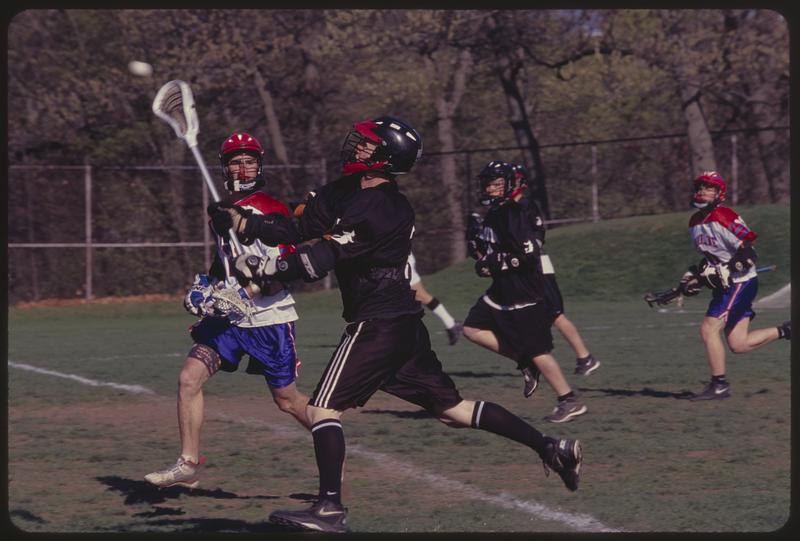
[190,317,297,389]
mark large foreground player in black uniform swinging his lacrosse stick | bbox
[231,117,582,532]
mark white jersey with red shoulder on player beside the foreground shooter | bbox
[217,192,298,327]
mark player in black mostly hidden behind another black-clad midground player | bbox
[510,163,600,378]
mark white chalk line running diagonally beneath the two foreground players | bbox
[8,361,621,532]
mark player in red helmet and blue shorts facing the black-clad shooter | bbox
[145,132,310,488]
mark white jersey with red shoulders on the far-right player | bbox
[689,206,757,283]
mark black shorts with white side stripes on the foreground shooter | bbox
[310,313,462,413]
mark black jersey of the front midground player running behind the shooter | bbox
[483,201,545,308]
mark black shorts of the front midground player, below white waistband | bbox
[464,297,553,362]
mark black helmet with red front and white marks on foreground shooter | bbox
[341,116,422,175]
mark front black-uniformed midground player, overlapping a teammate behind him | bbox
[464,160,587,423]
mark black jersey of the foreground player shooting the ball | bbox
[279,180,422,322]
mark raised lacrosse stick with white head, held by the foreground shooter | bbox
[153,79,244,262]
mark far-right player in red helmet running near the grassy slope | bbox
[680,171,792,400]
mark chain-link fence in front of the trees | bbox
[8,128,789,304]
